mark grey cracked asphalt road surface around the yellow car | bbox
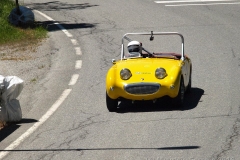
[1,0,240,160]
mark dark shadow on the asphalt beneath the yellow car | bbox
[117,88,204,113]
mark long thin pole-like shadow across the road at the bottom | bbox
[0,146,200,152]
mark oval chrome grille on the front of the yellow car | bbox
[125,83,160,94]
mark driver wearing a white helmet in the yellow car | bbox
[128,41,142,57]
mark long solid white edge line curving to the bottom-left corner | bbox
[0,89,72,159]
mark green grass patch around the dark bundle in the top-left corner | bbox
[0,0,47,45]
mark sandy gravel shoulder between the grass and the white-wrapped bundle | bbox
[0,38,53,129]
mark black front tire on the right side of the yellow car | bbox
[174,78,185,109]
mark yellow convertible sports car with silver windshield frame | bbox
[106,31,192,112]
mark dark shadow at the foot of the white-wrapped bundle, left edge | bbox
[0,118,37,142]
